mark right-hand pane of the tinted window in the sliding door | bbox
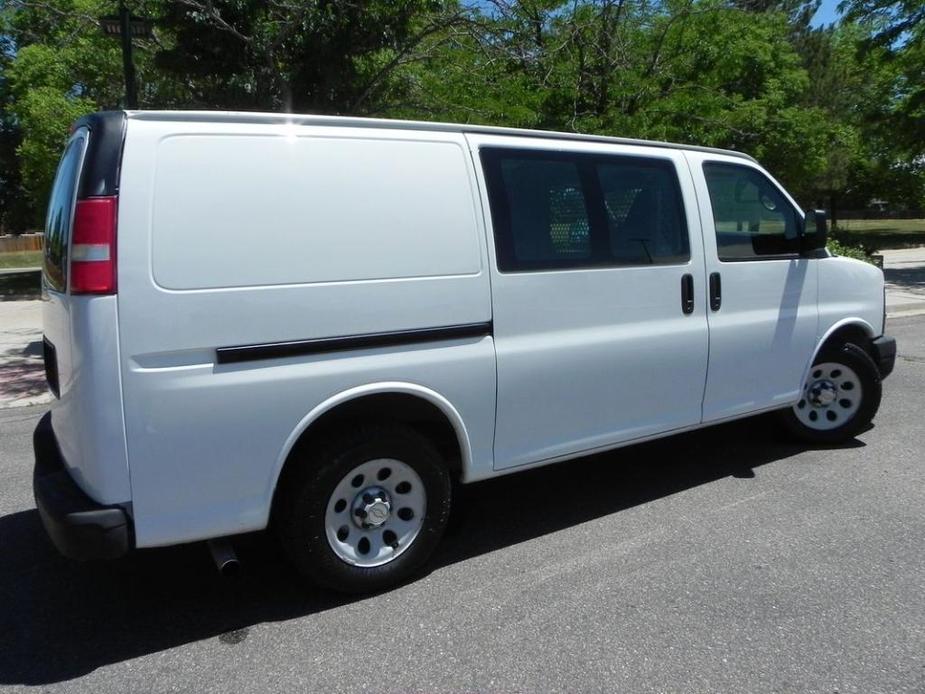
[596,159,691,265]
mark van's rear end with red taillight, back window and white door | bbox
[42,113,131,504]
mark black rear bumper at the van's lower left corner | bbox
[32,412,133,560]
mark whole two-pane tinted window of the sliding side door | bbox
[480,147,690,272]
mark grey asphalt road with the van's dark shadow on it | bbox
[0,317,925,694]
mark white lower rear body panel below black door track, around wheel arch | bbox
[127,346,494,547]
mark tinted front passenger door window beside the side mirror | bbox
[703,162,800,261]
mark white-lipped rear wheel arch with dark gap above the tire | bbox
[265,382,472,521]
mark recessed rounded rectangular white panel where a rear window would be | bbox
[152,133,480,289]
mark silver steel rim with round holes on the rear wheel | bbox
[324,458,427,567]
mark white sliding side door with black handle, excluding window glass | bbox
[468,135,708,470]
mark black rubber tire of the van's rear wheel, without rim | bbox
[274,424,452,593]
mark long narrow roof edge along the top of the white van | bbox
[126,111,758,163]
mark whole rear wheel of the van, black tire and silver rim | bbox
[276,425,451,593]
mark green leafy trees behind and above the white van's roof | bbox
[0,0,925,234]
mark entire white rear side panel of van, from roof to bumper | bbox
[118,118,495,547]
